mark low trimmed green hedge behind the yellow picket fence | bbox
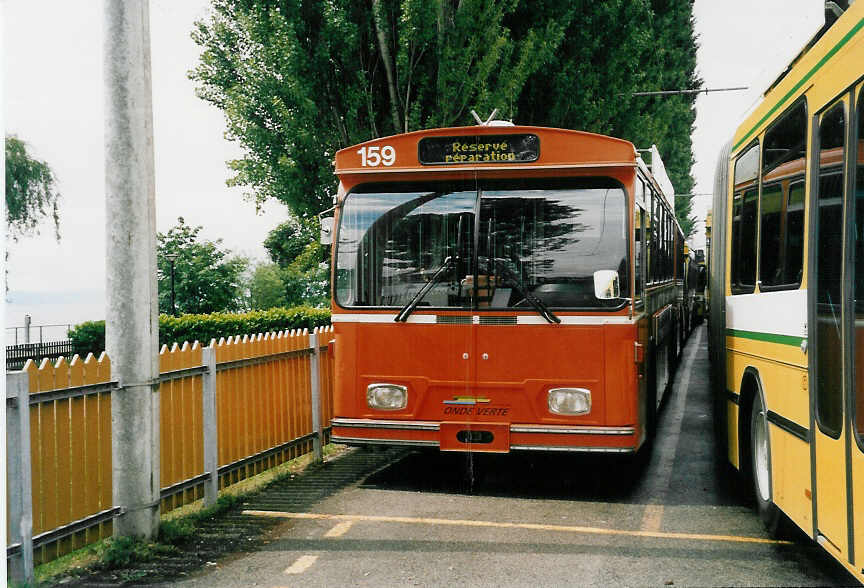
[69,306,330,357]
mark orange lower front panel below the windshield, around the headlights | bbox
[333,317,642,451]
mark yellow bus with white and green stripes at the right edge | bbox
[709,2,864,581]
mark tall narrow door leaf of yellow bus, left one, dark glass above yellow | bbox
[808,100,852,559]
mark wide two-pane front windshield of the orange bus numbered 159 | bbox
[335,178,629,310]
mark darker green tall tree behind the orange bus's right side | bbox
[510,0,701,235]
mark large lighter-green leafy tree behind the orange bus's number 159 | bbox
[190,0,564,217]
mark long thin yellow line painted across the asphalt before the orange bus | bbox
[243,510,792,545]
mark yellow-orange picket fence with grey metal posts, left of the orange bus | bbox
[6,327,333,580]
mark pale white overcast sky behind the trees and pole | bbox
[0,0,823,341]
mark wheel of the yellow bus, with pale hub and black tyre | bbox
[750,391,785,538]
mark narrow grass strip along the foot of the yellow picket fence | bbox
[35,444,347,585]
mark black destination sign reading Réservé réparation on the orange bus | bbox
[417,134,540,165]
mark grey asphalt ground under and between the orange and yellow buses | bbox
[177,328,854,587]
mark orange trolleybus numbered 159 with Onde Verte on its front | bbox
[332,121,683,453]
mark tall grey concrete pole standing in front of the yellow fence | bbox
[103,0,159,538]
